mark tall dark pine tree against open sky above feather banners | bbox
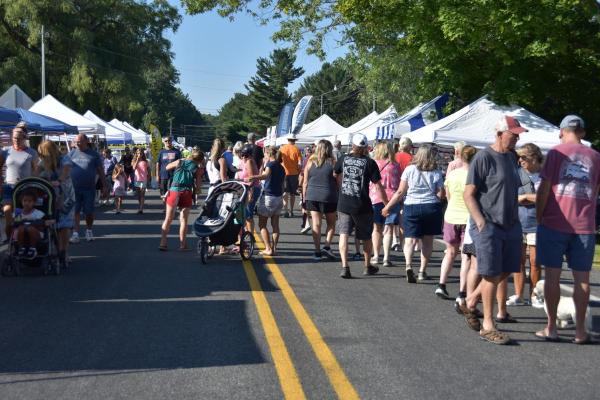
[246,49,304,133]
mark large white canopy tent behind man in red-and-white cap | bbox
[403,96,589,152]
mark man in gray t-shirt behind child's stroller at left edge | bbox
[0,123,38,241]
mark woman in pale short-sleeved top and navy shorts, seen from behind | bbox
[381,145,445,283]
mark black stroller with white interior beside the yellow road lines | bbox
[194,181,254,264]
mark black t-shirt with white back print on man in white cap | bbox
[334,154,381,214]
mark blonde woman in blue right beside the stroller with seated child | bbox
[38,140,75,268]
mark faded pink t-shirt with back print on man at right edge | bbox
[540,143,600,234]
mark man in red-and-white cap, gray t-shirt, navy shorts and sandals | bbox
[463,116,527,344]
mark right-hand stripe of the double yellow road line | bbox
[254,235,360,400]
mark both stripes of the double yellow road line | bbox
[243,235,360,400]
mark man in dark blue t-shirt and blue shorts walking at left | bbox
[67,133,108,243]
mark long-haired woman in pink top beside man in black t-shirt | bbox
[369,142,401,267]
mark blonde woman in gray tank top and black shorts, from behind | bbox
[302,140,338,261]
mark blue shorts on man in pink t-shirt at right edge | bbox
[536,225,596,272]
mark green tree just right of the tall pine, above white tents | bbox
[294,59,363,126]
